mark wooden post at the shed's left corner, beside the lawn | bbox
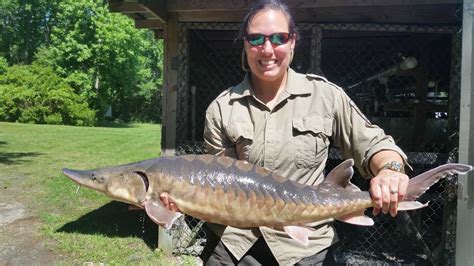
[158,13,178,255]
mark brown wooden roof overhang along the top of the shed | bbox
[109,0,463,30]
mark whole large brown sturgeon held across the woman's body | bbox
[63,155,472,245]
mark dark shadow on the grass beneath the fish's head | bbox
[57,201,158,249]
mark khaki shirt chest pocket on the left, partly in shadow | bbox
[226,122,254,161]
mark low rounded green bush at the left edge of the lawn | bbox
[0,64,95,126]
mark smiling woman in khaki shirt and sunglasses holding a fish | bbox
[198,0,408,265]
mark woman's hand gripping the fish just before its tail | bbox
[369,169,408,217]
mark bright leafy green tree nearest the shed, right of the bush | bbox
[49,0,162,121]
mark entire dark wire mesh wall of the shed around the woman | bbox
[174,23,460,264]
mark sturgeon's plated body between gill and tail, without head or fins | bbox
[150,155,371,227]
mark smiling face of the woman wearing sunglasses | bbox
[244,9,295,82]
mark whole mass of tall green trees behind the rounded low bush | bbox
[0,0,163,123]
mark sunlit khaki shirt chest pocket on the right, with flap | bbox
[293,115,332,168]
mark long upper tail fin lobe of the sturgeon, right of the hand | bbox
[404,163,472,201]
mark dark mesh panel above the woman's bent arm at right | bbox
[321,31,452,153]
